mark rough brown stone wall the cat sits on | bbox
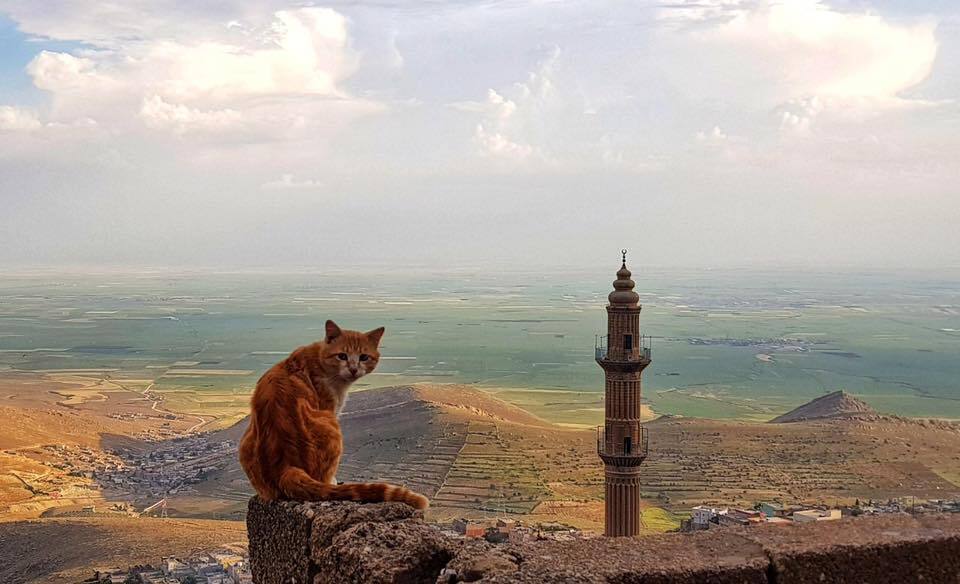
[247,497,960,584]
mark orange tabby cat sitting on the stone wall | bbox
[240,320,428,509]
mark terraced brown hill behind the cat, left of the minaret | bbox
[191,384,572,515]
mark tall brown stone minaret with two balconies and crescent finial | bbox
[596,250,650,536]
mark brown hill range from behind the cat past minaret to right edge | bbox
[171,384,960,531]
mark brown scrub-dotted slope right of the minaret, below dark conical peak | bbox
[642,414,960,509]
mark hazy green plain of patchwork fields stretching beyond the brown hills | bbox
[0,265,960,424]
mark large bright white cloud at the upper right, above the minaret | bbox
[664,0,937,130]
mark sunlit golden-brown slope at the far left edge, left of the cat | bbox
[0,374,197,521]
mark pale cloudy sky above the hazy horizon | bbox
[0,0,960,269]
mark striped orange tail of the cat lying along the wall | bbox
[280,467,430,509]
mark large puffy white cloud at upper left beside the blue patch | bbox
[16,7,383,142]
